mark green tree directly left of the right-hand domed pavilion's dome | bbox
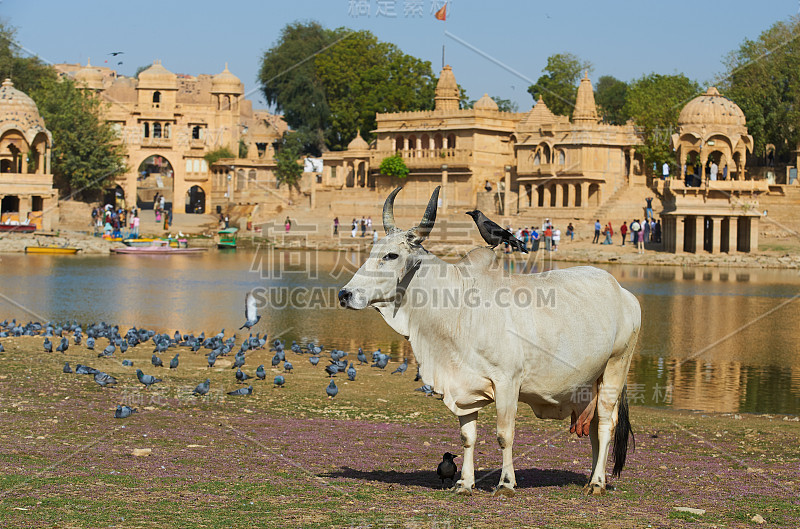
[623,73,700,173]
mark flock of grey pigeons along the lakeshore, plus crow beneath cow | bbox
[0,293,455,480]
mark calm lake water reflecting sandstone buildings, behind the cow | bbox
[0,250,800,414]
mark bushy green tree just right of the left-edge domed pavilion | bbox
[30,79,125,194]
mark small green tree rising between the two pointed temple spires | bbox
[528,53,592,116]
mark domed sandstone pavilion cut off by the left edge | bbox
[0,79,58,230]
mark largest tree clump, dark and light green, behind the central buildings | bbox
[259,22,436,155]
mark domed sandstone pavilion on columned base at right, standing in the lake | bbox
[653,86,769,253]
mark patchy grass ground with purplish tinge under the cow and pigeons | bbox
[0,337,800,528]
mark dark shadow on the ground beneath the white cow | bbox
[319,466,589,490]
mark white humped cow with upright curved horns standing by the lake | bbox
[339,188,641,495]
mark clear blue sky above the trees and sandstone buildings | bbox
[0,0,800,111]
